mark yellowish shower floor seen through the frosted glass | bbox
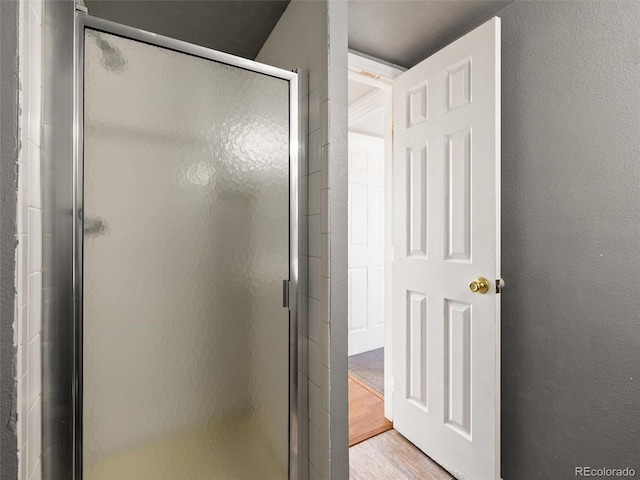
[84,418,287,480]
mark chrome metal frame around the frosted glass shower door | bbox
[42,1,302,480]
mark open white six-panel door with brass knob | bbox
[392,18,500,480]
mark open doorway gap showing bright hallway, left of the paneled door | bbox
[348,59,392,447]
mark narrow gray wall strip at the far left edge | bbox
[0,0,18,480]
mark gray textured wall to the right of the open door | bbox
[498,1,640,480]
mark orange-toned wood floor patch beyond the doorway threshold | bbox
[349,374,393,447]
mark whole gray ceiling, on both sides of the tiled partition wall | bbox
[85,0,513,68]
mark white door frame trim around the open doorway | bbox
[348,50,406,421]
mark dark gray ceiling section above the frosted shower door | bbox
[84,0,289,60]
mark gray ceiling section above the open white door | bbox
[348,0,513,68]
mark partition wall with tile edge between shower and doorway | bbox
[257,0,348,479]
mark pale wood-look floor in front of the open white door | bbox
[349,430,455,480]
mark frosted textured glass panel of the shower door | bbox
[83,29,289,480]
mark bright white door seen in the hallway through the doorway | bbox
[348,133,384,355]
